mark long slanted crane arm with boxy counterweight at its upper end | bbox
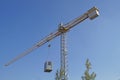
[5,7,99,66]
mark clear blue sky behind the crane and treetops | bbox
[0,0,120,80]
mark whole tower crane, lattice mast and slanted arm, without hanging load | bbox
[5,7,99,80]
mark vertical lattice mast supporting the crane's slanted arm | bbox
[59,24,68,80]
